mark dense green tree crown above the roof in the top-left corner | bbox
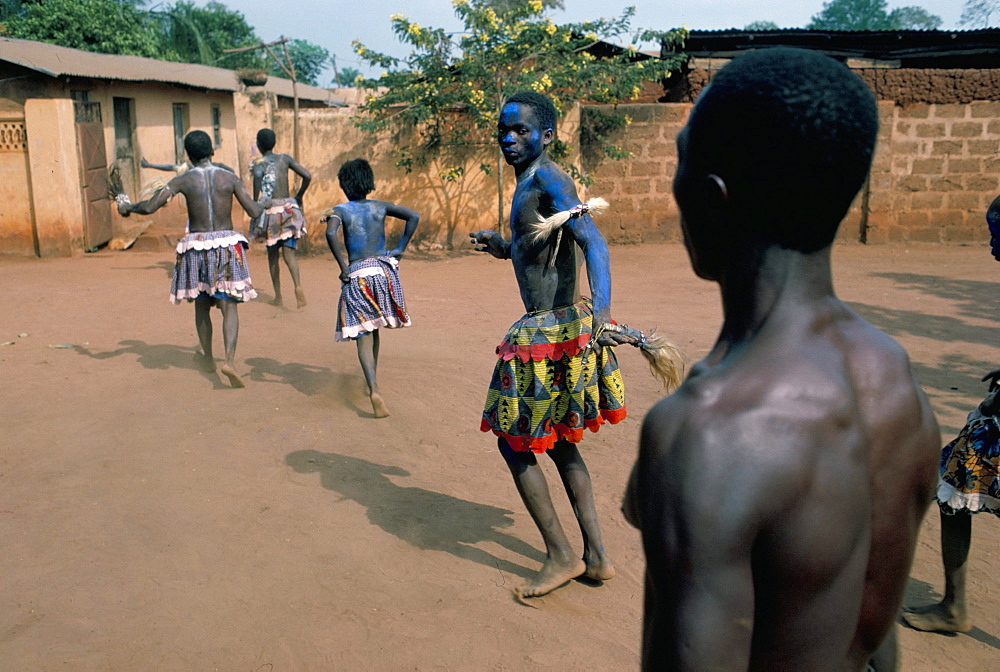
[5,0,159,58]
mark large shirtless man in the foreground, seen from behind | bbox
[624,49,940,672]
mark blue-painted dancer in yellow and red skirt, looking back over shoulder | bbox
[470,92,634,597]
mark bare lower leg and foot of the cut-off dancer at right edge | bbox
[903,511,972,632]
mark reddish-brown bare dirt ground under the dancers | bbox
[0,240,1000,672]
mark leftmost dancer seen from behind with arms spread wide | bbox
[118,131,264,387]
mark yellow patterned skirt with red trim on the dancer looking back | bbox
[480,299,626,453]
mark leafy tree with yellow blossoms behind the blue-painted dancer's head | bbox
[354,0,687,179]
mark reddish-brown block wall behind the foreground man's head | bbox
[582,91,1000,244]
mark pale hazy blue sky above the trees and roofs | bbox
[209,0,964,86]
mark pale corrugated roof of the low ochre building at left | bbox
[0,37,345,107]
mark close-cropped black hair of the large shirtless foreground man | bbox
[686,48,878,252]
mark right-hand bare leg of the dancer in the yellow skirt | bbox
[549,441,615,581]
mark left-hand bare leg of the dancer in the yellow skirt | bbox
[497,439,587,597]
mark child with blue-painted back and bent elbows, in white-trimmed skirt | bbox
[323,159,420,418]
